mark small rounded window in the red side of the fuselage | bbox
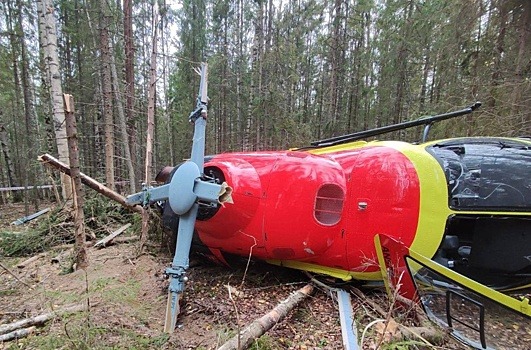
[314,184,345,225]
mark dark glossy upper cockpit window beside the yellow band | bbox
[427,138,531,211]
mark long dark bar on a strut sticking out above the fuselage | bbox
[311,102,481,147]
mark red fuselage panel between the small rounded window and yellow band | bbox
[347,147,420,279]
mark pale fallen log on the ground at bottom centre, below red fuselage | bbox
[218,284,313,350]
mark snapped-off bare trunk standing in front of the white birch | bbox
[63,94,88,269]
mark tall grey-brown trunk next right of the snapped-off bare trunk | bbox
[100,0,114,190]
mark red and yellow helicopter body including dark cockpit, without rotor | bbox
[181,138,531,289]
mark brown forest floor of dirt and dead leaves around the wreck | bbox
[0,201,516,349]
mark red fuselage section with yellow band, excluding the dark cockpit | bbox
[196,142,448,280]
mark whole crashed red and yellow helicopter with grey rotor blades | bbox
[128,64,531,348]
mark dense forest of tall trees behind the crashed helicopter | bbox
[0,0,531,199]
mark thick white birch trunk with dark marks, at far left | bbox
[37,0,72,199]
